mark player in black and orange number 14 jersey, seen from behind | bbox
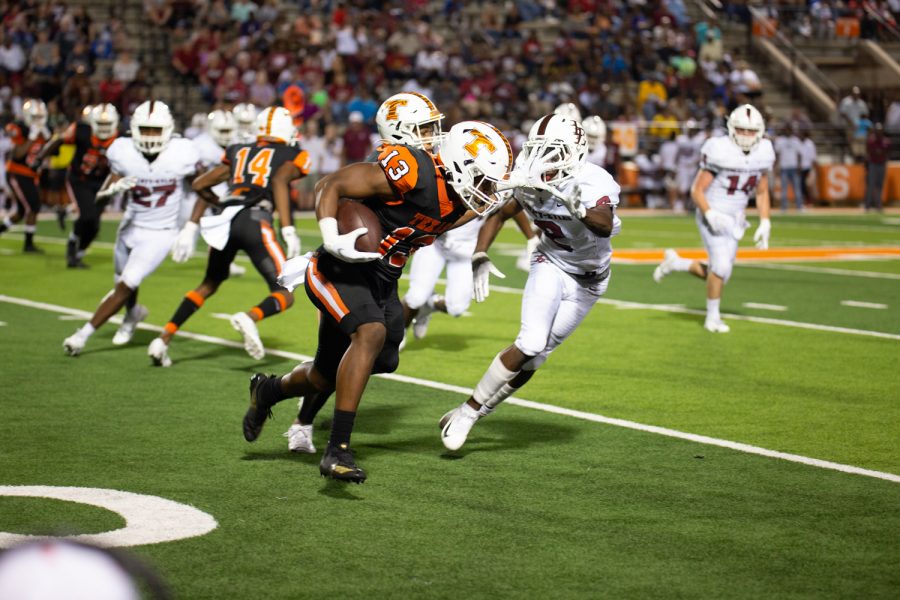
[147,107,310,367]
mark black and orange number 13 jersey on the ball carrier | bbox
[362,144,466,280]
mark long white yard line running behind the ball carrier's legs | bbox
[0,294,900,483]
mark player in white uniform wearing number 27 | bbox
[63,100,199,356]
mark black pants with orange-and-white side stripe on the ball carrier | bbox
[305,248,404,382]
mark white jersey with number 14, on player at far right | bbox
[700,135,775,216]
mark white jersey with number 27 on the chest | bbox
[106,137,199,229]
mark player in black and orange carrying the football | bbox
[244,121,512,483]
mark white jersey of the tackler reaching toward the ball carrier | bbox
[513,163,622,275]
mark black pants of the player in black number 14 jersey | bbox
[206,207,285,292]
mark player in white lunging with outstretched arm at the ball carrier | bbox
[440,114,622,450]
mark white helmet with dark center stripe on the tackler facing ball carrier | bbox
[517,114,588,185]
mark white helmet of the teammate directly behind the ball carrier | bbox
[375,92,444,150]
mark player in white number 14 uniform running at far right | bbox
[653,104,775,333]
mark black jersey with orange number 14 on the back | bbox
[222,142,310,206]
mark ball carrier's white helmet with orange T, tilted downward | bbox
[438,121,512,215]
